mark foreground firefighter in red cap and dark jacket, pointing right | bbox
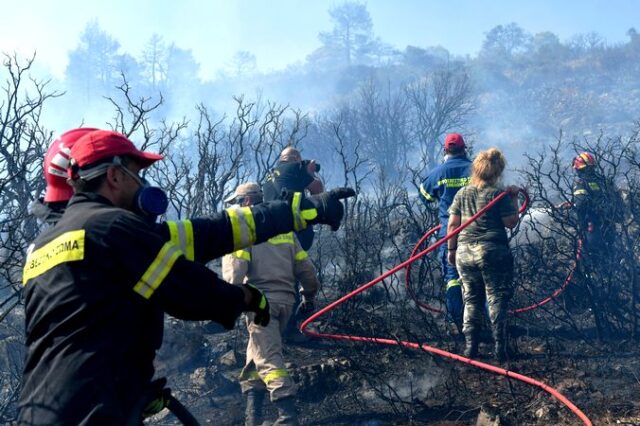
[17,131,353,425]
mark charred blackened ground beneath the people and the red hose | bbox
[147,306,640,426]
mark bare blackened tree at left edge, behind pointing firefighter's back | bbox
[0,54,60,422]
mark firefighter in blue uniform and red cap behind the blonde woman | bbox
[420,133,471,332]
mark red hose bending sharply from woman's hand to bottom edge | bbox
[300,191,592,426]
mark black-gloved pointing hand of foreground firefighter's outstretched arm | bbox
[287,188,356,231]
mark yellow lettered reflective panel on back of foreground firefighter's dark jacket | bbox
[22,229,85,285]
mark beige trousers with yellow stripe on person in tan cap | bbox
[240,302,297,401]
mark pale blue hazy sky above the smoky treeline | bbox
[0,0,640,78]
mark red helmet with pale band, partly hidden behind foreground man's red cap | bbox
[44,127,98,203]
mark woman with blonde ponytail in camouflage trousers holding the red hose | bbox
[447,148,519,362]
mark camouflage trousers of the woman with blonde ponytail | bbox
[456,242,513,341]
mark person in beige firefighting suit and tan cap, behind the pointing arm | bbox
[222,183,320,426]
